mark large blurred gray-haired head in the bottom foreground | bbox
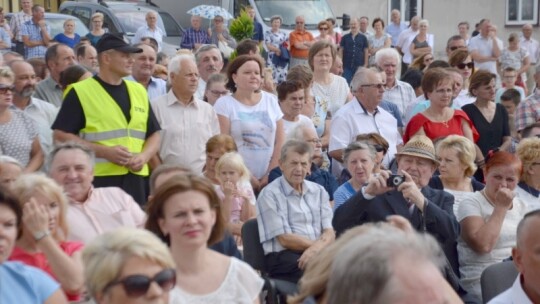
[327,224,450,304]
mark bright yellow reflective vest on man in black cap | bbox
[73,78,150,176]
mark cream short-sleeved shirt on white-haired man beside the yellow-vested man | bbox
[150,90,219,172]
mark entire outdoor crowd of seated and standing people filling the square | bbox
[0,0,540,303]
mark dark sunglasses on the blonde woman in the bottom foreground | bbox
[104,269,176,298]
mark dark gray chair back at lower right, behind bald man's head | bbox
[480,261,519,303]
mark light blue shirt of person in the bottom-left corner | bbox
[0,262,60,304]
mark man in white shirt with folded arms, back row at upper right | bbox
[469,19,503,78]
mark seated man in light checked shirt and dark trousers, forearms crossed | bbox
[256,140,335,283]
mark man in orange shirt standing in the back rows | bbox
[289,16,315,68]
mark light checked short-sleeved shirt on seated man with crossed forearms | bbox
[256,176,333,254]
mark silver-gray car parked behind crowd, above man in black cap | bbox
[59,1,184,56]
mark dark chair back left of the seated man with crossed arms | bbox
[242,218,266,272]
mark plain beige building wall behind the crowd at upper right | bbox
[328,0,540,59]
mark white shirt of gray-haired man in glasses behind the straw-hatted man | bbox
[328,97,403,176]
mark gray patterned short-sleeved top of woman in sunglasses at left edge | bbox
[0,110,38,167]
